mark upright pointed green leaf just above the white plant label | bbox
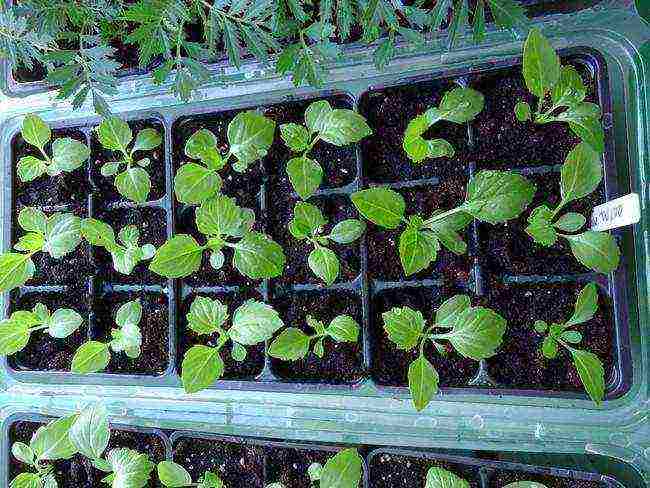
[560,142,603,202]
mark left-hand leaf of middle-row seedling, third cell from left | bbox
[149,234,203,278]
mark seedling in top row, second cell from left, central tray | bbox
[97,116,162,203]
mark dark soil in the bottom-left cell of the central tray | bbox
[8,291,90,371]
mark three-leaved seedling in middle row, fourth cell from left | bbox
[289,202,366,286]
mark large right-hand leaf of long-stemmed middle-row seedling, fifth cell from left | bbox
[463,170,535,224]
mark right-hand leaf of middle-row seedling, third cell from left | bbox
[233,232,286,279]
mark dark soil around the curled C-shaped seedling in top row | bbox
[359,79,470,183]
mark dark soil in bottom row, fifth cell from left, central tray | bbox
[369,287,479,387]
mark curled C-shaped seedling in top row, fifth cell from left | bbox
[402,87,485,164]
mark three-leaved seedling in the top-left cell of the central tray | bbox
[16,114,90,182]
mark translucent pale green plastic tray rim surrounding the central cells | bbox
[0,3,650,484]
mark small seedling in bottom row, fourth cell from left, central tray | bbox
[269,315,359,361]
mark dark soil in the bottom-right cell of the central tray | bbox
[487,279,615,392]
